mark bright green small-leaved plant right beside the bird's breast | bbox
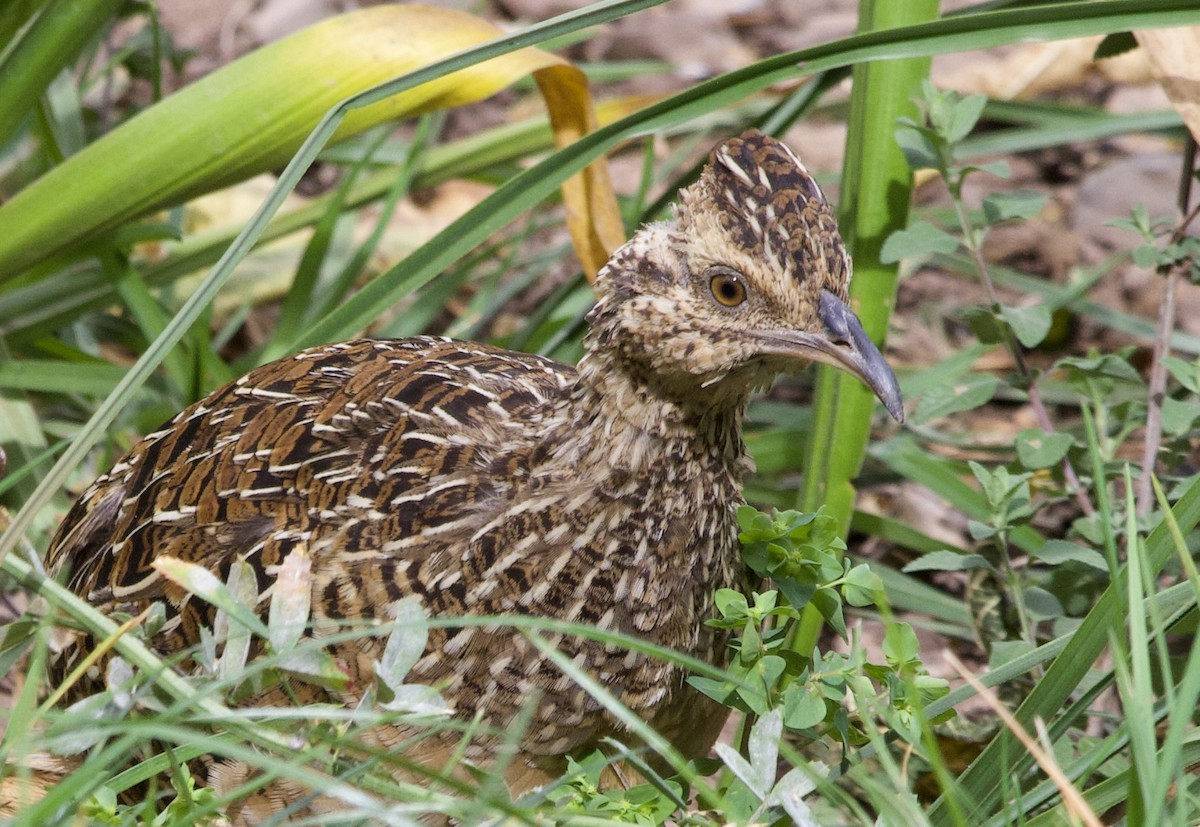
[689,507,949,782]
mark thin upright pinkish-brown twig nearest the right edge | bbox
[1138,134,1200,516]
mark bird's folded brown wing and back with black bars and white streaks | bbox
[48,337,574,651]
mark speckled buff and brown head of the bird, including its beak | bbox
[589,131,904,420]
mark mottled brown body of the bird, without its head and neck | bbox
[56,337,746,768]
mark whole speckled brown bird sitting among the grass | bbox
[35,133,900,816]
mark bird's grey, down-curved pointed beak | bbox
[760,290,904,423]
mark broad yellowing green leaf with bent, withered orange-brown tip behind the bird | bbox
[0,5,623,282]
